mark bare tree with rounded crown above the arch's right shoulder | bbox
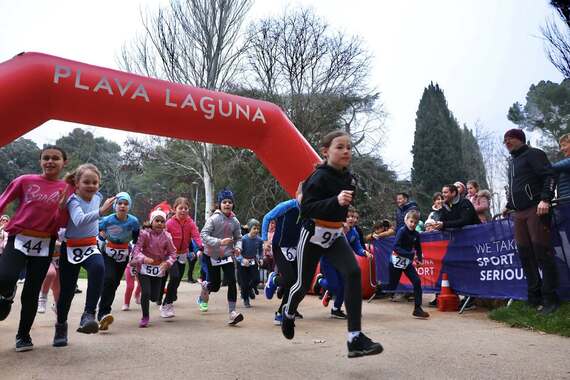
[242,9,385,154]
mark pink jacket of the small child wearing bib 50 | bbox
[131,230,176,269]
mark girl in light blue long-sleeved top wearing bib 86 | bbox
[53,164,115,347]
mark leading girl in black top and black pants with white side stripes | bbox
[281,131,382,357]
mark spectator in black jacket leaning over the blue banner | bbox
[434,185,481,230]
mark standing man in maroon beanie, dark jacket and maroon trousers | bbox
[503,129,560,315]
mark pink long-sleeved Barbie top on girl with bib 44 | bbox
[0,174,73,236]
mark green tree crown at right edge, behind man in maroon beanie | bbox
[507,79,570,150]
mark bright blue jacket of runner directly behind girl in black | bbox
[261,199,301,248]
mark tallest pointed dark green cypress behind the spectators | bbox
[412,83,467,210]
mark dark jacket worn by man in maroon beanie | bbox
[507,145,556,211]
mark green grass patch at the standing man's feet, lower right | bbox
[489,301,570,337]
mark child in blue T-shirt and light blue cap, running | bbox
[97,192,140,331]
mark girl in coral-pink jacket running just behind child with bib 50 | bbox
[160,197,203,318]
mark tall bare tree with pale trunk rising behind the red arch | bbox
[119,0,252,220]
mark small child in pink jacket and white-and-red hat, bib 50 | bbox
[131,210,177,327]
